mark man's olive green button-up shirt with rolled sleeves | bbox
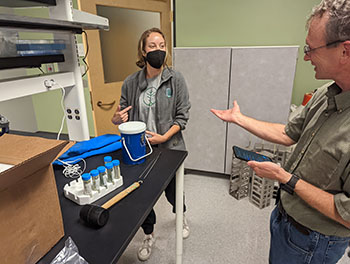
[281,83,350,237]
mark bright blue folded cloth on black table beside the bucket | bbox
[52,134,122,165]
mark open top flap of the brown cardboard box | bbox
[0,134,68,191]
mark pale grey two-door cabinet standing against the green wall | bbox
[174,46,298,174]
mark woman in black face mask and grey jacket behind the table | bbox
[112,28,190,261]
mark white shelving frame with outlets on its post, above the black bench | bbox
[0,0,108,141]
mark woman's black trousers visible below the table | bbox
[141,175,186,235]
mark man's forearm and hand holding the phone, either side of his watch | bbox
[248,161,350,228]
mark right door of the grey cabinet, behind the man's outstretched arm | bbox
[225,46,298,173]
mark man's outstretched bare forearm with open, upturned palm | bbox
[210,101,295,146]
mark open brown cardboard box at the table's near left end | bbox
[0,134,68,264]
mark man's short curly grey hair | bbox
[306,0,350,43]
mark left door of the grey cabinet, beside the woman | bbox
[174,48,231,173]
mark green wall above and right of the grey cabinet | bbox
[175,0,326,105]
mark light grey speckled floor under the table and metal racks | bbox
[118,174,350,264]
